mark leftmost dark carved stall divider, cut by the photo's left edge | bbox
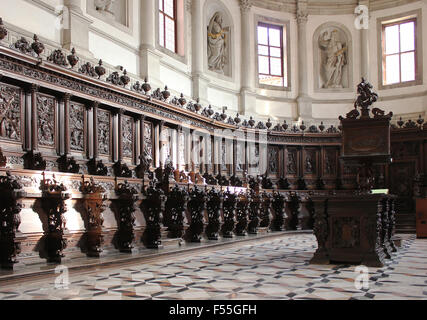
[0,172,26,269]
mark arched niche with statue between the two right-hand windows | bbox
[313,22,353,92]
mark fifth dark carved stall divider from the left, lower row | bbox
[141,181,166,249]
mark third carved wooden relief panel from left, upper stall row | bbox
[69,102,86,152]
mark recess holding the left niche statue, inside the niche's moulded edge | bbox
[207,7,231,77]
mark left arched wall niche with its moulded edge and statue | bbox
[204,0,234,78]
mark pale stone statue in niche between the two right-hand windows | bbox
[319,30,347,89]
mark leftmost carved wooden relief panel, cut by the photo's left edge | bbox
[0,83,23,142]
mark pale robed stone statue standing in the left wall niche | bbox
[208,12,227,73]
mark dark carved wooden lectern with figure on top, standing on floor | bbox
[311,79,397,267]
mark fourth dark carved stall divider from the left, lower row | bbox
[114,179,138,253]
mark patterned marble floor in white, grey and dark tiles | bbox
[0,234,427,300]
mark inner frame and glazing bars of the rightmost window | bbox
[381,17,418,87]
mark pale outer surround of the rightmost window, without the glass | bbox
[377,9,424,90]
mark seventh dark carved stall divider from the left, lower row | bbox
[187,186,207,242]
